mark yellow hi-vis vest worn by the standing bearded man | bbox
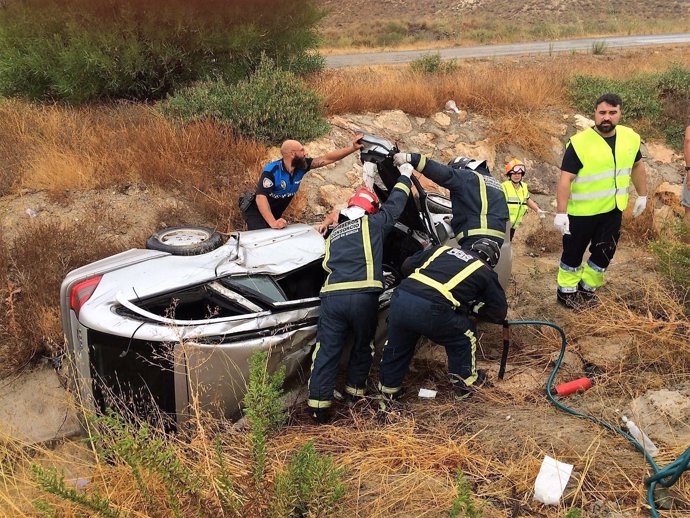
[568,126,640,216]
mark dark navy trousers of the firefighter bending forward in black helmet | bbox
[379,289,477,394]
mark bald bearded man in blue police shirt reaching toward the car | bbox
[240,133,364,230]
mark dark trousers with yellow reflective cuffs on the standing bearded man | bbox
[558,209,623,293]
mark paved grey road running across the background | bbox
[326,33,690,68]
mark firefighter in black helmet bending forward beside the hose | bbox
[379,237,508,399]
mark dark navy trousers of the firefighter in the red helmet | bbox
[308,291,379,408]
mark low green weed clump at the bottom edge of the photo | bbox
[271,442,345,518]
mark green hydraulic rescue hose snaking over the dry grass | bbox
[502,320,690,518]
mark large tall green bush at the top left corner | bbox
[0,0,324,103]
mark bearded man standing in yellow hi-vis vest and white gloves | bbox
[554,93,647,308]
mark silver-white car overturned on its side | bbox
[60,136,511,425]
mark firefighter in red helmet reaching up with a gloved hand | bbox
[307,164,412,422]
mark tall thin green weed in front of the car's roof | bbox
[244,352,287,487]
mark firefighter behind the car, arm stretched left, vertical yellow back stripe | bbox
[393,153,509,246]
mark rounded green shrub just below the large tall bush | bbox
[160,59,329,144]
